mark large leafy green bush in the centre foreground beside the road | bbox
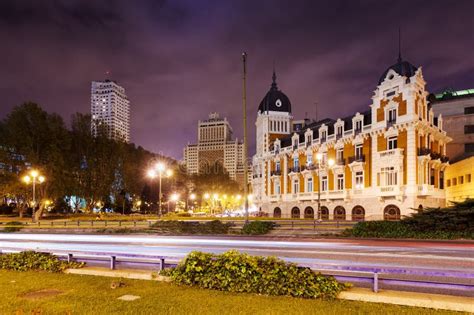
[165,251,347,299]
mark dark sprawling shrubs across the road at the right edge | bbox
[344,199,474,239]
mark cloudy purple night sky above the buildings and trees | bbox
[0,0,474,159]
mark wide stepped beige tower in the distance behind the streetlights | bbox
[183,113,252,185]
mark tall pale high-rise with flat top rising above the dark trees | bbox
[91,80,130,142]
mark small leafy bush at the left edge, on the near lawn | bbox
[0,251,84,272]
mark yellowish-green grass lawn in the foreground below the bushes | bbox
[0,270,459,315]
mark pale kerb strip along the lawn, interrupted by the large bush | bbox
[65,267,474,314]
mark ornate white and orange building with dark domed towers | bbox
[252,58,451,220]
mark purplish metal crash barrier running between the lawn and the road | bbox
[0,247,474,297]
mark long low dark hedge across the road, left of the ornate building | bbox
[152,220,233,234]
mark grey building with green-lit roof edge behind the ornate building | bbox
[429,89,474,162]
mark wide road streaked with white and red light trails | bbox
[0,233,474,275]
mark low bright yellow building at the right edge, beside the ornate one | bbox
[446,156,474,202]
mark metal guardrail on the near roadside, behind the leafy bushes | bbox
[0,248,474,296]
